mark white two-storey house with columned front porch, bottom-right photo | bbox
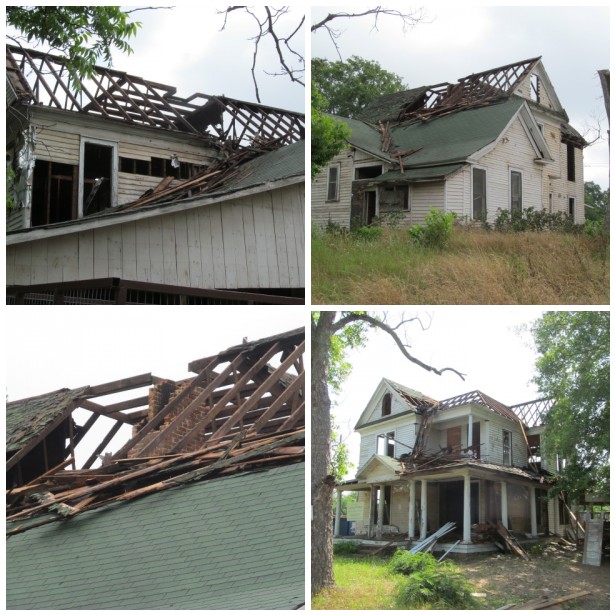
[335,378,568,552]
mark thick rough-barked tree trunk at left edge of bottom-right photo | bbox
[311,311,335,595]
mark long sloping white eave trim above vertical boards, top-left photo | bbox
[6,174,305,246]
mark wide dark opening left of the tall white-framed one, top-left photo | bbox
[31,160,79,226]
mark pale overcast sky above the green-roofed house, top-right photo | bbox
[312,3,610,189]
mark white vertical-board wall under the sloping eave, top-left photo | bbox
[7,184,305,289]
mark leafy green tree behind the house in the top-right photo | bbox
[312,56,407,117]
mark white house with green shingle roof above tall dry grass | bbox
[312,58,586,228]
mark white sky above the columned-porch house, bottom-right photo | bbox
[333,306,560,476]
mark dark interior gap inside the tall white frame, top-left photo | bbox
[83,143,113,216]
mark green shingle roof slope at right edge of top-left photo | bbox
[206,141,305,196]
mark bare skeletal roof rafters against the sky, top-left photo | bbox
[6,45,305,147]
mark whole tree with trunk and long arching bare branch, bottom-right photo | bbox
[311,311,463,595]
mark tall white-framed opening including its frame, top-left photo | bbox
[79,139,118,216]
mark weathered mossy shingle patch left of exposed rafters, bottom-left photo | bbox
[6,387,88,452]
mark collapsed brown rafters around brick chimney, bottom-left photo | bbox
[7,328,305,522]
